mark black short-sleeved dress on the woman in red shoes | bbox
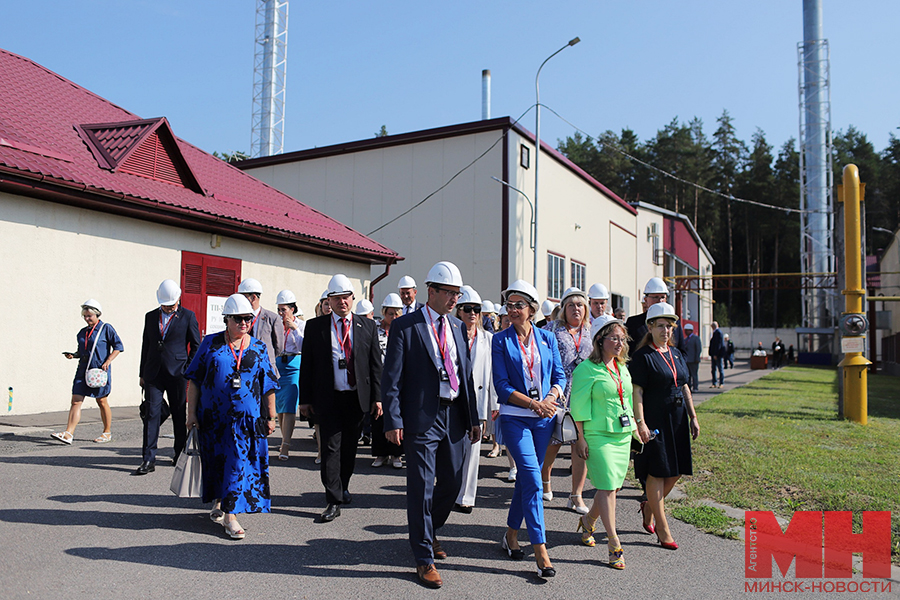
[628,344,693,480]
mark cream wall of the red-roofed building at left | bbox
[0,193,369,415]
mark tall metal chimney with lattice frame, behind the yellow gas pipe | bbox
[797,0,835,328]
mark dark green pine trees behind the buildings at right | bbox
[557,111,900,327]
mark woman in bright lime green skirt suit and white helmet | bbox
[570,315,635,569]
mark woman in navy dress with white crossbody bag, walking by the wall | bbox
[50,298,125,444]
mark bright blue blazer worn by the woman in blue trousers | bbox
[491,324,566,404]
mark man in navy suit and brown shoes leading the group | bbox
[382,261,481,588]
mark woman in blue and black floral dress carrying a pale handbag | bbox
[184,294,278,540]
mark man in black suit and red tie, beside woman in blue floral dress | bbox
[300,273,381,522]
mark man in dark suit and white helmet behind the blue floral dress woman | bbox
[134,279,200,475]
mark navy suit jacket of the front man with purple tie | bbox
[381,310,478,437]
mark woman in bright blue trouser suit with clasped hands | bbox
[491,279,566,578]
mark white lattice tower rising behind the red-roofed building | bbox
[250,0,288,158]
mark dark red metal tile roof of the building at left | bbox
[0,49,399,263]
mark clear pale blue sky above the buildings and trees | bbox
[0,0,900,162]
